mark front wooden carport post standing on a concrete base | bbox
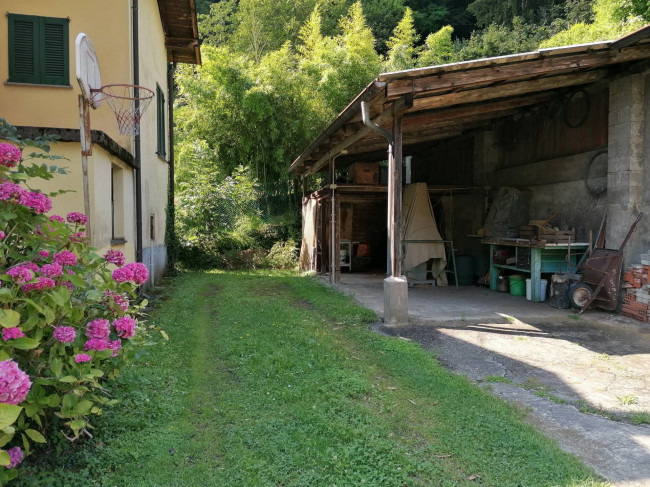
[388,112,402,277]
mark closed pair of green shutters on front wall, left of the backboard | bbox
[7,14,70,86]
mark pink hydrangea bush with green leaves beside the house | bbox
[0,130,148,485]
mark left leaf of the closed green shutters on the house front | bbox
[8,14,39,83]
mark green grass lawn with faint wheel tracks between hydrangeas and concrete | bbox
[20,272,607,487]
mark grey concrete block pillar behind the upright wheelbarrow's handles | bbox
[607,74,650,264]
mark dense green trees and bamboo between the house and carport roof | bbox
[176,0,650,263]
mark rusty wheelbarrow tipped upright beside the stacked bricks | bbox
[569,213,643,313]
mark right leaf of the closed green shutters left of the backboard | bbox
[40,17,70,85]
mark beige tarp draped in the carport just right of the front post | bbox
[402,183,447,286]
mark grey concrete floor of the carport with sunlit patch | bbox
[330,274,650,487]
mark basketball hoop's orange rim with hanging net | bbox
[91,84,155,135]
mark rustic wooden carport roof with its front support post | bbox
[289,26,650,324]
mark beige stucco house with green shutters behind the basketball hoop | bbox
[0,0,200,284]
